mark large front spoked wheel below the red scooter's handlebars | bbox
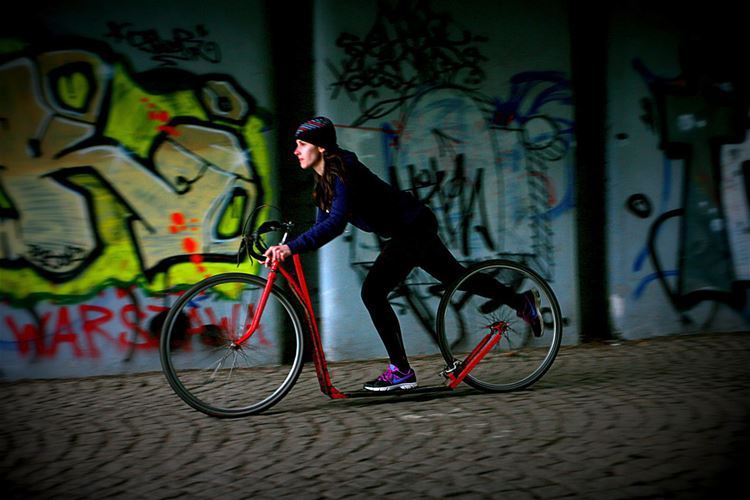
[159,273,303,417]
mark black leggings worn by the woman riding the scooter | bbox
[362,209,516,370]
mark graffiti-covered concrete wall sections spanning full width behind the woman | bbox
[0,0,750,379]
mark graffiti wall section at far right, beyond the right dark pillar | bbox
[608,3,750,338]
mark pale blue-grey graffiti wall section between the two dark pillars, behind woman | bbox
[316,1,577,359]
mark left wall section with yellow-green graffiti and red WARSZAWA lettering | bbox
[0,2,278,378]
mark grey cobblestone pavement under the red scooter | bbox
[0,333,750,499]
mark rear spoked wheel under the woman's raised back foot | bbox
[437,259,563,392]
